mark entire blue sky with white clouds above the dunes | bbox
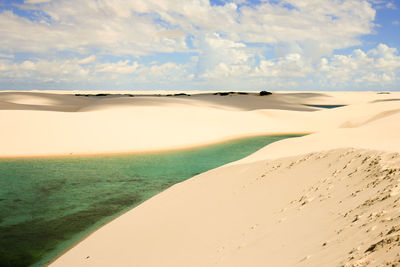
[0,0,400,91]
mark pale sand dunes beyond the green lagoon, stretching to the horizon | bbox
[0,92,400,157]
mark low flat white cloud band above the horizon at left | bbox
[0,55,193,84]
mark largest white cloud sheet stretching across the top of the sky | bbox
[0,0,375,58]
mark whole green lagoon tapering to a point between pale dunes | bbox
[0,135,298,266]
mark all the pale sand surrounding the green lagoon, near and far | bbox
[0,92,400,266]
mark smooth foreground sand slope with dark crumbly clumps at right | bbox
[53,149,400,266]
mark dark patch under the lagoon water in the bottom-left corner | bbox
[0,195,139,266]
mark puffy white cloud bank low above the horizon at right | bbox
[191,44,400,89]
